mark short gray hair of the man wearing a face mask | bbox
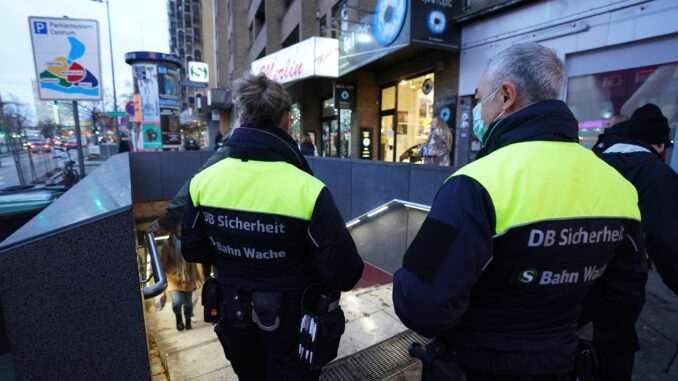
[485,43,565,103]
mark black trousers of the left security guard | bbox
[218,298,320,381]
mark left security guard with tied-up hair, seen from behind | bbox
[182,74,363,380]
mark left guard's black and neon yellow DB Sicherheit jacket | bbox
[181,126,363,292]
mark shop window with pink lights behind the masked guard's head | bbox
[567,63,678,160]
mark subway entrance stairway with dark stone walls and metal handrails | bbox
[0,151,678,381]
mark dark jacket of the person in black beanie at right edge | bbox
[599,140,678,293]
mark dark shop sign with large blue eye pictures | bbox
[339,0,462,76]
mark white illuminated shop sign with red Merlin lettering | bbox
[251,37,339,83]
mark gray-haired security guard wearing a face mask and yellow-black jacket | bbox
[393,44,647,381]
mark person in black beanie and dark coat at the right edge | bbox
[580,104,678,381]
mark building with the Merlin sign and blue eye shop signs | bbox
[210,0,529,162]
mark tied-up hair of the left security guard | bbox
[233,73,292,127]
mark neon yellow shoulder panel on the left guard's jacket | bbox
[190,158,325,220]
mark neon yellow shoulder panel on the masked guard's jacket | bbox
[448,141,640,235]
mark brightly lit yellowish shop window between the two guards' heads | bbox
[381,74,434,162]
